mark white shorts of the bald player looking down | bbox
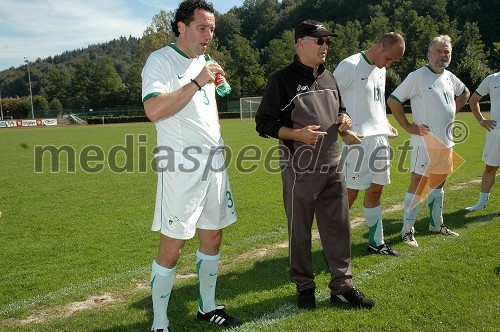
[342,135,391,190]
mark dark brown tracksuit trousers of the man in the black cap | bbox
[282,166,353,294]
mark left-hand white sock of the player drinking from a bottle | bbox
[151,260,176,330]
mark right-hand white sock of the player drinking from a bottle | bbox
[196,250,220,312]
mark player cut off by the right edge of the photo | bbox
[466,72,500,211]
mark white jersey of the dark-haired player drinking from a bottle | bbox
[142,44,219,154]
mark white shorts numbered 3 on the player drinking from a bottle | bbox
[151,152,236,240]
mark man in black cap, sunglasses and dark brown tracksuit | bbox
[255,20,374,309]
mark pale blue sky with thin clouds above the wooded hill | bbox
[0,0,244,71]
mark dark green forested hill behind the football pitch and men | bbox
[0,0,500,113]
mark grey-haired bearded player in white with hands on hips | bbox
[387,35,470,247]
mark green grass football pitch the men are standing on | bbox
[0,114,500,331]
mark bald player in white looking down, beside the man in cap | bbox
[333,32,405,255]
